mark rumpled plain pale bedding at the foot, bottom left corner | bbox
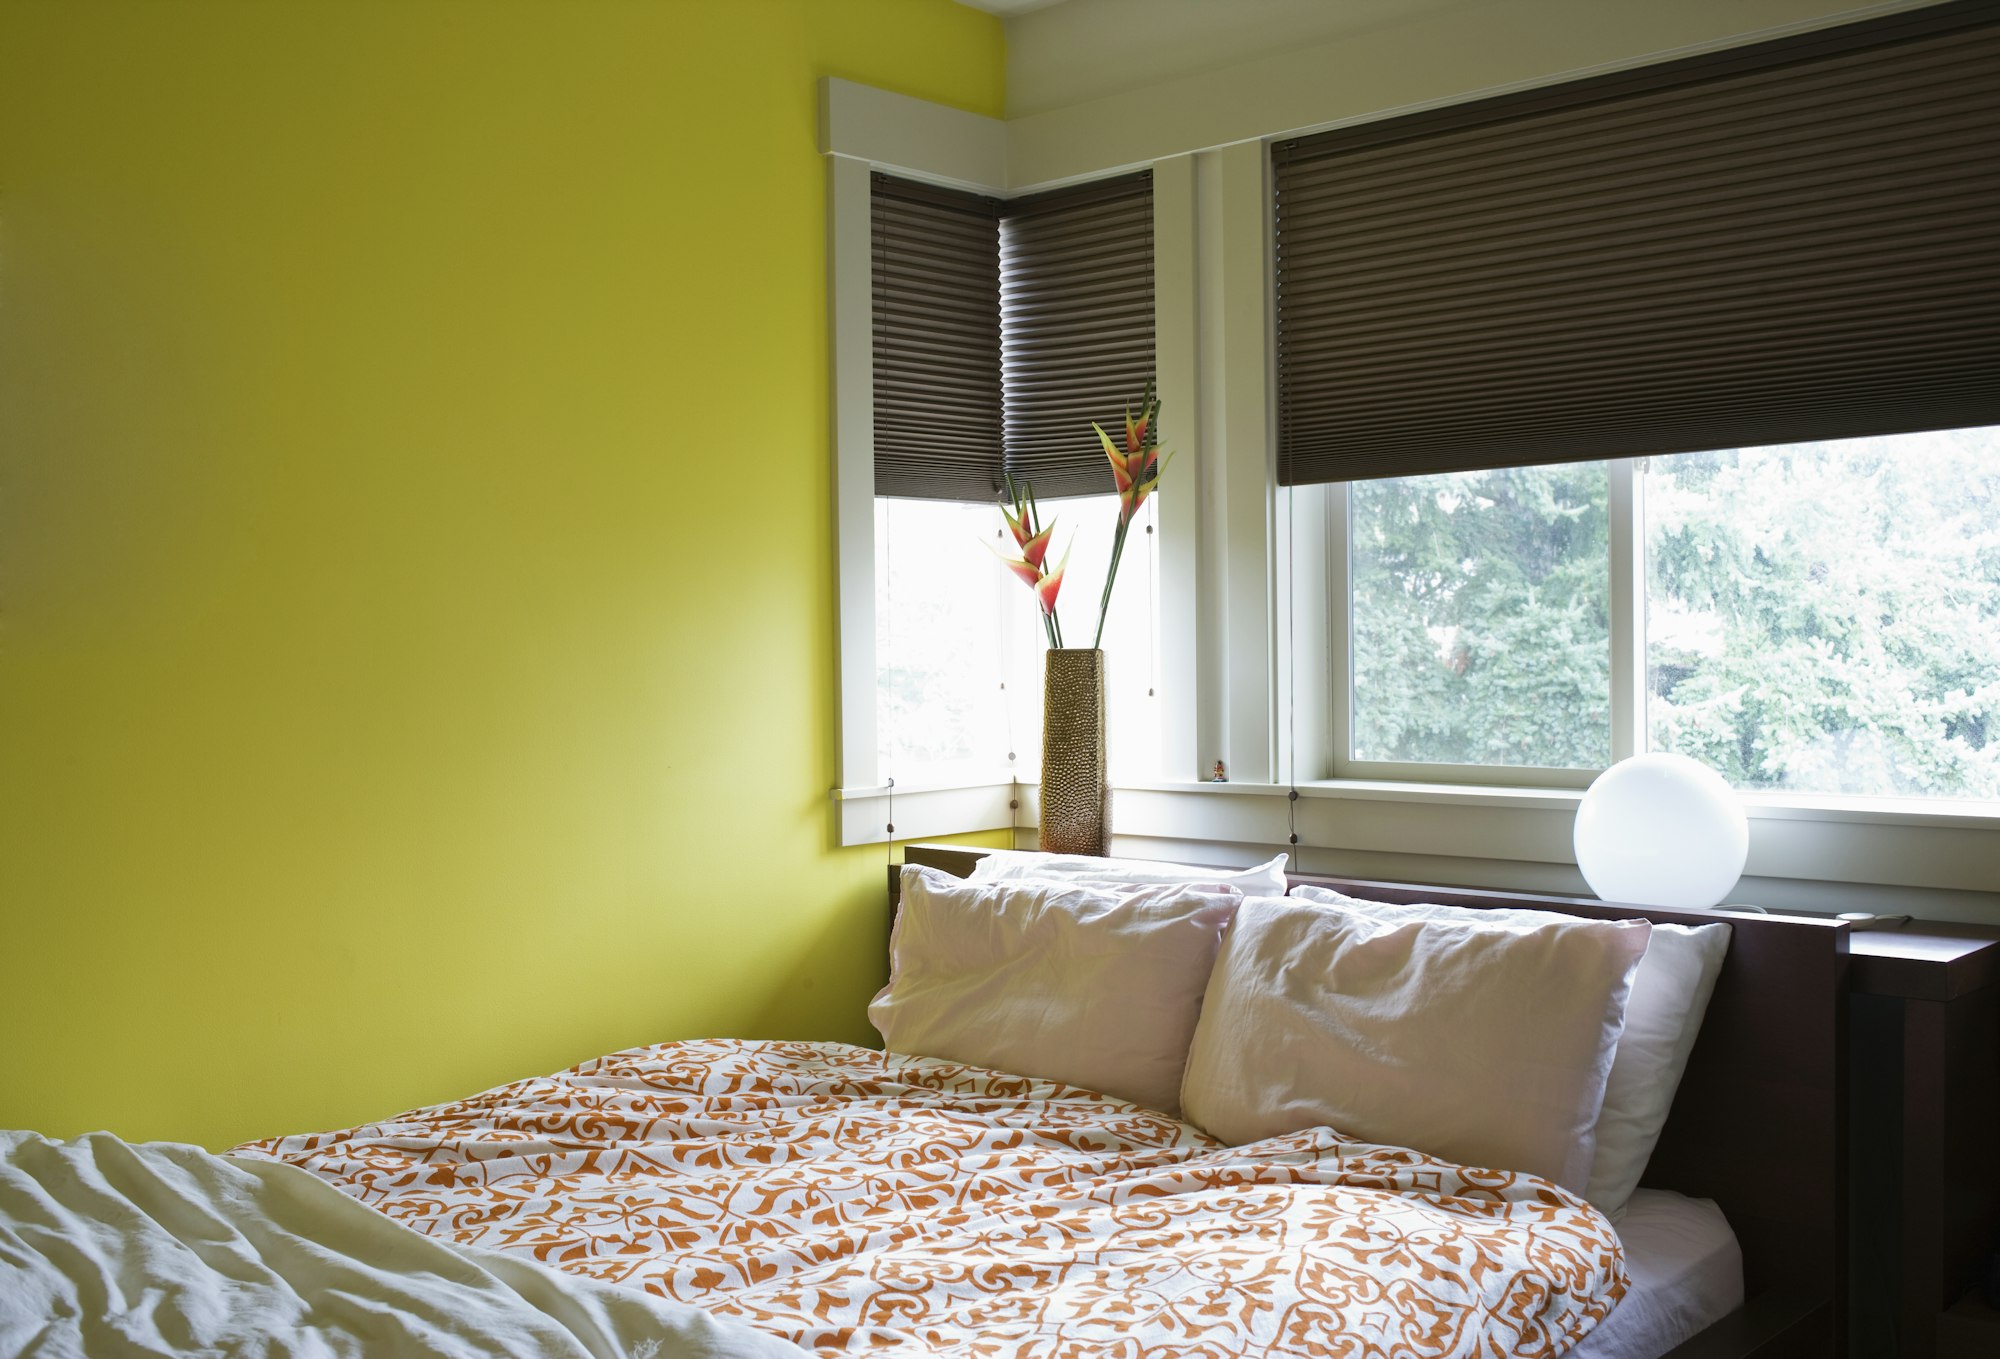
[0,1133,804,1359]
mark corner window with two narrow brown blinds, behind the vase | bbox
[870,172,1158,787]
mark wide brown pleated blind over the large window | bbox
[1272,0,2000,484]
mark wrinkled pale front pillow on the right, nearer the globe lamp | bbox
[1180,897,1650,1189]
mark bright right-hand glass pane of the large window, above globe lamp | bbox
[1644,430,2000,799]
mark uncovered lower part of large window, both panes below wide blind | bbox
[1328,428,2000,801]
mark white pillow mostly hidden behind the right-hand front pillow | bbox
[1292,887,1730,1219]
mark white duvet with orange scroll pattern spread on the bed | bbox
[244,1041,1626,1359]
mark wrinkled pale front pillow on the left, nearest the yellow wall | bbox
[868,865,1242,1115]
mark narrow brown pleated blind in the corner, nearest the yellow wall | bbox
[872,174,1000,500]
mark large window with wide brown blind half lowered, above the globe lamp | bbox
[1270,6,2000,799]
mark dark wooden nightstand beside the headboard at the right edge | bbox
[1848,921,2000,1359]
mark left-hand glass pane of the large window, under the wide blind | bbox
[1348,462,1610,769]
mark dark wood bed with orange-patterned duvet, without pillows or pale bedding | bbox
[0,847,1844,1359]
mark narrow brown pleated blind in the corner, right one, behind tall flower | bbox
[1000,170,1154,496]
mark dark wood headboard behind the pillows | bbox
[890,845,1848,1355]
